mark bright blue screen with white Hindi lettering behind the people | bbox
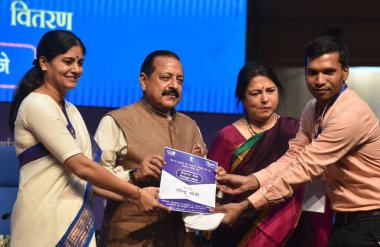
[0,0,247,113]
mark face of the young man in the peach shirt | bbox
[305,51,349,106]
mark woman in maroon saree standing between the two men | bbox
[208,62,332,247]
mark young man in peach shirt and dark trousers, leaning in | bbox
[214,36,380,246]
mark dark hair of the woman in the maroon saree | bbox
[235,61,284,111]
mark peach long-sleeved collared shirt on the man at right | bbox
[248,88,380,212]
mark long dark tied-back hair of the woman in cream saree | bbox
[8,30,86,131]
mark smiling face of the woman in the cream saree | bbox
[40,45,84,95]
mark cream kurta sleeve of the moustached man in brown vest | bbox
[94,115,129,181]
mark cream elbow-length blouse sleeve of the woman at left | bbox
[21,97,82,163]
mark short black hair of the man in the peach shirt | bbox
[304,36,348,67]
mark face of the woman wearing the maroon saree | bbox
[243,75,279,124]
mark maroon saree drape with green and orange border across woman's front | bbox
[212,117,303,247]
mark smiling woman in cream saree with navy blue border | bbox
[9,30,168,247]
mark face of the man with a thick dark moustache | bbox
[139,56,184,112]
